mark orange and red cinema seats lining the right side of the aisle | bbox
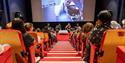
[70,29,125,63]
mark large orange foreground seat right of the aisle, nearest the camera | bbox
[98,29,125,63]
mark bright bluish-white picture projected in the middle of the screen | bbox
[41,0,84,22]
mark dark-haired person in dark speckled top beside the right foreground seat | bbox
[84,10,112,63]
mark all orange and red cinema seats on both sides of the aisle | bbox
[0,29,125,63]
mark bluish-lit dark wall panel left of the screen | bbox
[8,0,26,20]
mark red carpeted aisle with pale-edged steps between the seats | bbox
[40,41,84,63]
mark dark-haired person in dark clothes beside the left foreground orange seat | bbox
[12,20,34,63]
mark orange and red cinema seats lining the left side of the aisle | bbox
[0,29,51,63]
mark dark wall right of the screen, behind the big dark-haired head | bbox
[95,0,125,23]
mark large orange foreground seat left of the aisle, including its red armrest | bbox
[0,29,35,63]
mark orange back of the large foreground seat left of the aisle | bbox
[0,29,27,63]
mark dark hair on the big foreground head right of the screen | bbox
[97,10,112,23]
